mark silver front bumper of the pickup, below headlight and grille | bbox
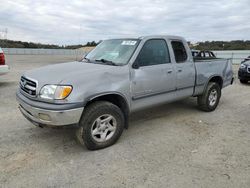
[17,93,84,127]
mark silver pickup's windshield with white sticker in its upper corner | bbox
[85,39,139,65]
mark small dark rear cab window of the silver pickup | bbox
[171,41,188,63]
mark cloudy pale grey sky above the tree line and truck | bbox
[0,0,250,45]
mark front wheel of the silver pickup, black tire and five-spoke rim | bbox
[76,101,125,150]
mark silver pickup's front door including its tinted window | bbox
[131,39,176,108]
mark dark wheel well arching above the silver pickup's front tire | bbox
[86,94,129,128]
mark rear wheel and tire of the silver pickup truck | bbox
[197,82,221,112]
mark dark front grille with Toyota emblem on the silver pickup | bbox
[20,76,37,96]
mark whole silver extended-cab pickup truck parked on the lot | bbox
[17,36,233,150]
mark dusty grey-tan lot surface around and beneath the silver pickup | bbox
[0,55,250,188]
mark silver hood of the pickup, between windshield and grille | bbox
[24,61,124,88]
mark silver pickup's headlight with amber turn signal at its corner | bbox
[39,85,72,100]
